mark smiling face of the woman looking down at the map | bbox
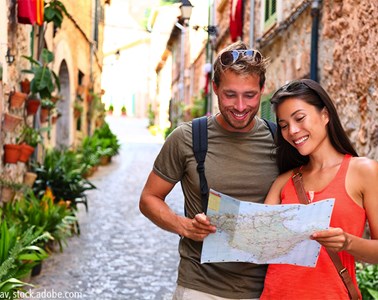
[276,98,329,156]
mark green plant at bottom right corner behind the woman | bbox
[356,263,378,300]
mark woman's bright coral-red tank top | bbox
[260,155,366,300]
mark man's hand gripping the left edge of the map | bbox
[183,213,216,242]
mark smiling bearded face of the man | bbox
[213,71,264,132]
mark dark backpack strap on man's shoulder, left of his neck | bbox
[192,116,209,213]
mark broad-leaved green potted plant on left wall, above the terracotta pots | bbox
[22,48,60,99]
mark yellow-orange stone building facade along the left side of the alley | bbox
[0,0,110,181]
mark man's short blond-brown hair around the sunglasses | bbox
[213,41,269,88]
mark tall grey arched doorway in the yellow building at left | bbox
[56,60,72,149]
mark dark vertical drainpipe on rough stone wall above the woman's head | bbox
[310,0,321,81]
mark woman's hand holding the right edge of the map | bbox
[311,228,350,252]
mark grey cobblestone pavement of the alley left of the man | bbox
[29,117,183,300]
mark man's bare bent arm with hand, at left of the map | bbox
[139,171,215,241]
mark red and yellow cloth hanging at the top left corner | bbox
[17,0,45,26]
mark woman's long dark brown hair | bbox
[270,79,358,173]
